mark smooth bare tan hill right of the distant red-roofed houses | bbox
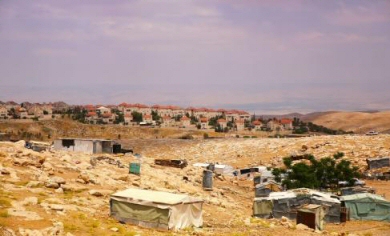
[303,111,390,133]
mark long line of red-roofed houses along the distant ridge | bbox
[0,101,293,131]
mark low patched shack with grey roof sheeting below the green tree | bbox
[253,188,341,223]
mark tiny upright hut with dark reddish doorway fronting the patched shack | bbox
[297,204,325,230]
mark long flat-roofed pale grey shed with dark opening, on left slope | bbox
[54,138,113,154]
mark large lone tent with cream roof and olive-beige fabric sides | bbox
[110,188,203,230]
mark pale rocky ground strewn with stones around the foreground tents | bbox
[0,135,390,236]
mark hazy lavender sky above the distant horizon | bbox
[0,0,390,113]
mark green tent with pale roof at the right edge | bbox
[340,193,390,221]
